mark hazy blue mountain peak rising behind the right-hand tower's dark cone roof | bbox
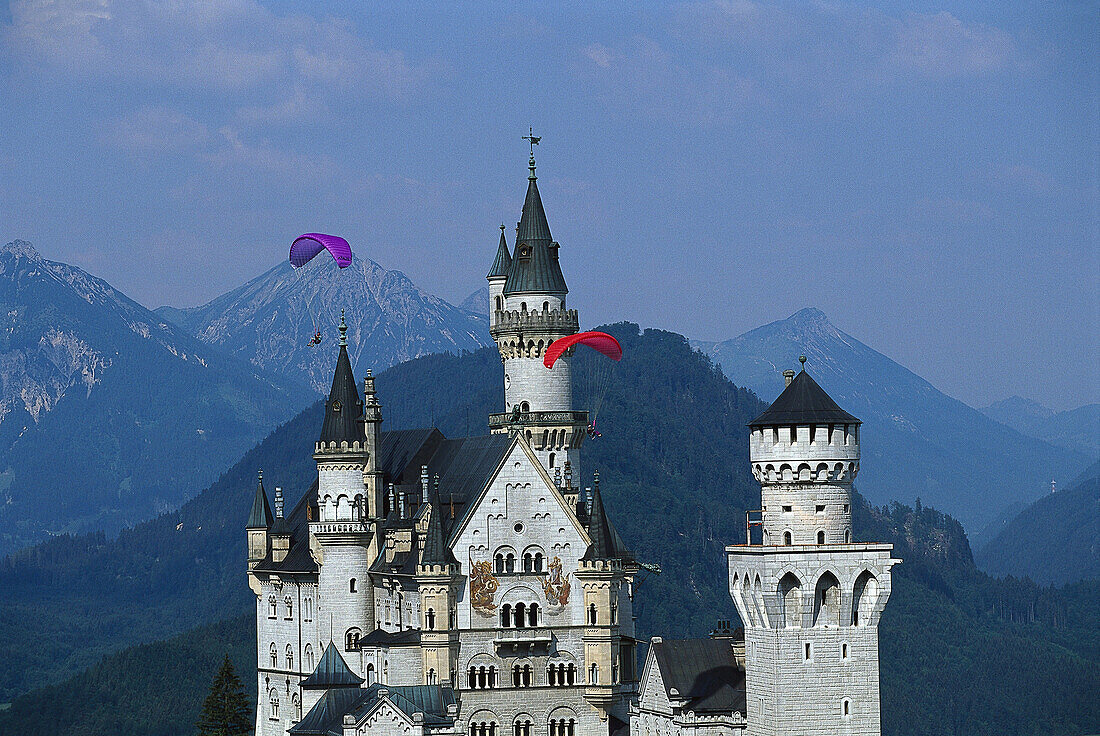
[694,308,1088,536]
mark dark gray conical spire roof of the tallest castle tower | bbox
[504,174,569,296]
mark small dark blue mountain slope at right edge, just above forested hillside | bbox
[977,476,1100,585]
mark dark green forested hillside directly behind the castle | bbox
[0,325,1100,736]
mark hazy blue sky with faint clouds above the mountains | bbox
[0,0,1100,408]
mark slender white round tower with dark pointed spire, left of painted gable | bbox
[309,315,382,650]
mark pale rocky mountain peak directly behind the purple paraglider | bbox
[156,254,492,392]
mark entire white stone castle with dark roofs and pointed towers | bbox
[246,146,897,736]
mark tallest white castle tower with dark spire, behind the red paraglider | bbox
[487,146,587,476]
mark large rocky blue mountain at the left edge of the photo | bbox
[0,241,308,554]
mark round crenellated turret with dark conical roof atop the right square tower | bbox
[749,358,860,545]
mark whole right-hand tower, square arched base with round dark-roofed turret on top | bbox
[726,358,900,736]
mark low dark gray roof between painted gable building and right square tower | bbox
[651,639,745,714]
